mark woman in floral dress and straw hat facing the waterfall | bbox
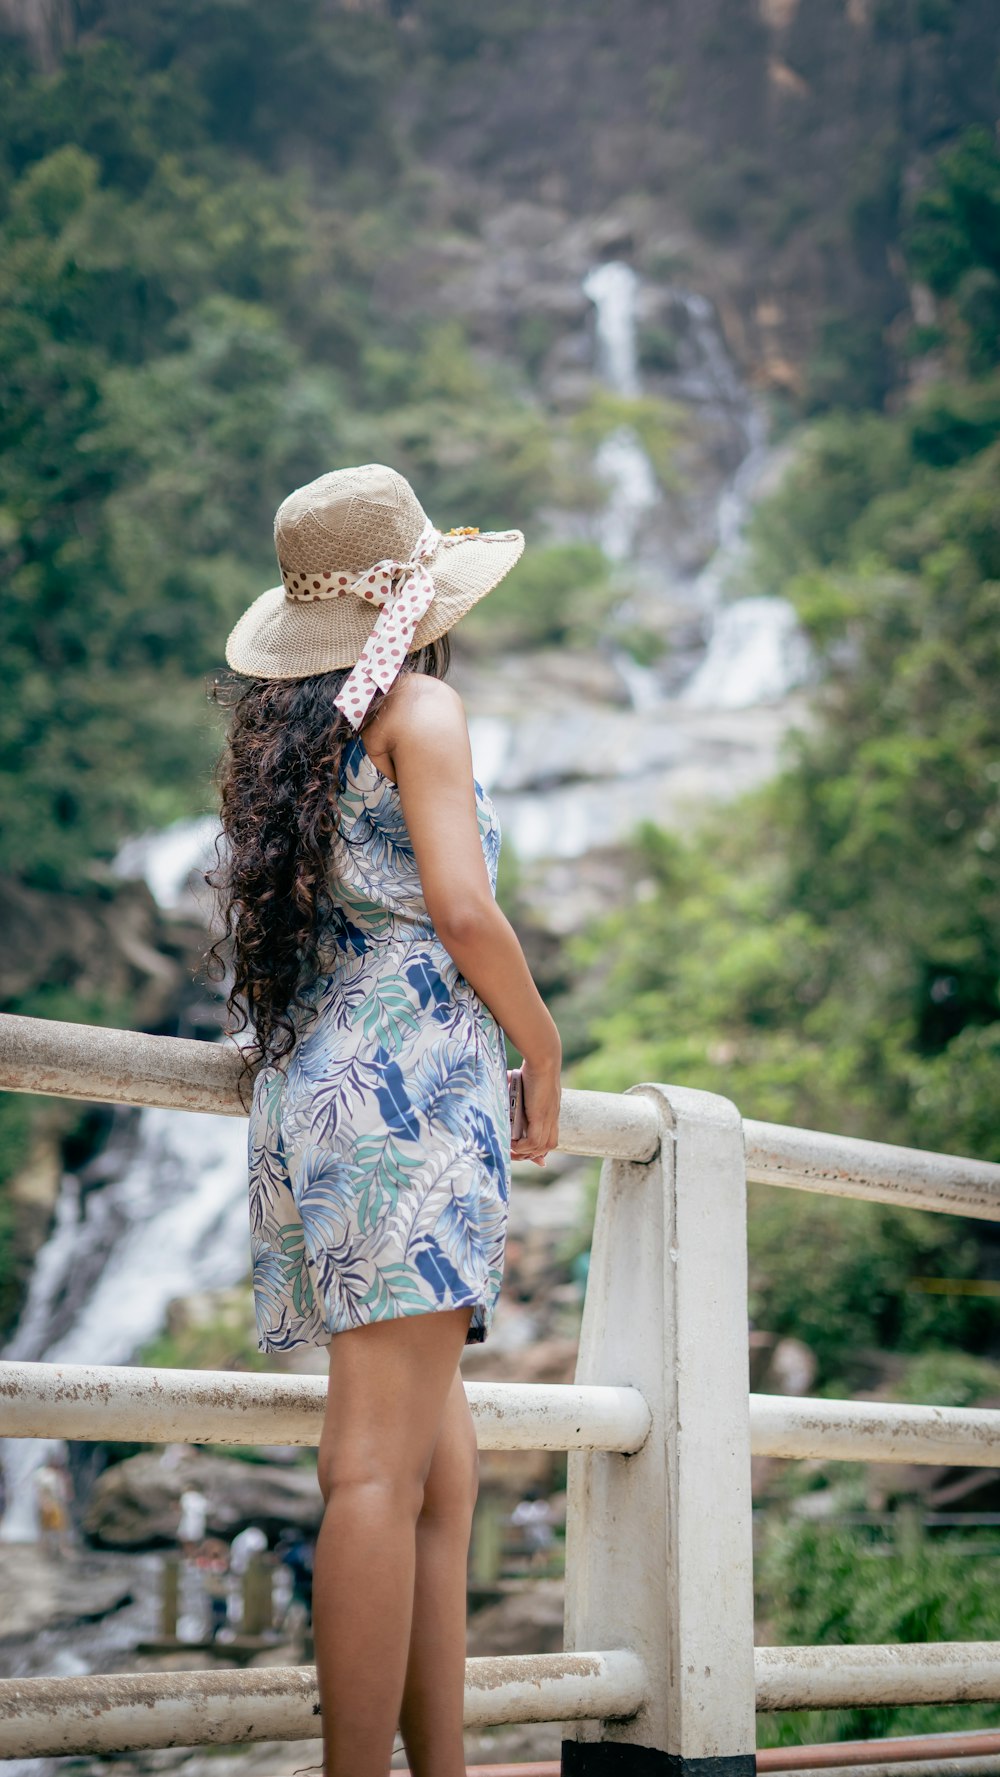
[213,464,561,1777]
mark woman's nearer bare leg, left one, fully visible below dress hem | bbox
[313,1308,471,1777]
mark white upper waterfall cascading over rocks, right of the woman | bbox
[480,261,810,874]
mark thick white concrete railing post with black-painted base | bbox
[563,1084,755,1777]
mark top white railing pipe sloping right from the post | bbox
[742,1118,1000,1221]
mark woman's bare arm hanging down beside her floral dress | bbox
[387,673,563,1160]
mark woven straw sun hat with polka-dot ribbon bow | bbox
[226,462,524,729]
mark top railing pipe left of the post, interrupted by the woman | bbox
[0,1015,659,1160]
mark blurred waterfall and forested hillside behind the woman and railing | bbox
[0,0,1000,1777]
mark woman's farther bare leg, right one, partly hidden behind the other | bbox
[400,1374,480,1777]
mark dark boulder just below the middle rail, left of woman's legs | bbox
[83,1446,323,1550]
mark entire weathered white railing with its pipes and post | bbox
[0,1018,1000,1777]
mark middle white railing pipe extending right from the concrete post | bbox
[750,1395,1000,1468]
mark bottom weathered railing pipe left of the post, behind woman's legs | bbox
[0,1649,648,1757]
